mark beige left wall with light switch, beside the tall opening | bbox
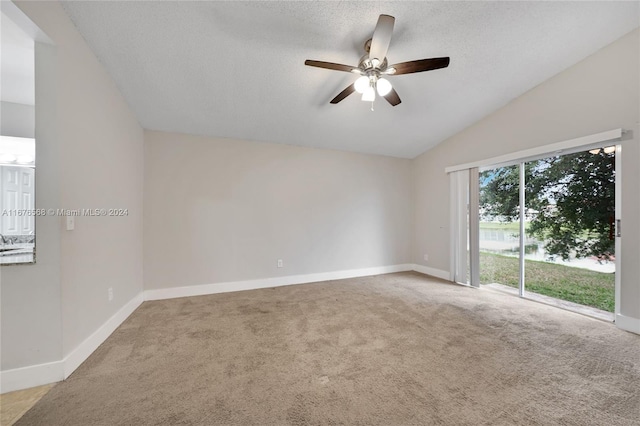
[1,2,143,380]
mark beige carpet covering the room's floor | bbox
[17,273,640,426]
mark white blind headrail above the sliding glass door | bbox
[444,129,622,173]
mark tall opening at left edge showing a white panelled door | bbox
[0,7,36,265]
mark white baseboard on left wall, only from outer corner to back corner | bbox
[62,293,143,379]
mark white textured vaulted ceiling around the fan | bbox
[63,1,639,158]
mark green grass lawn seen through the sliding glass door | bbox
[480,252,615,312]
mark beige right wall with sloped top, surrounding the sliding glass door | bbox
[414,30,640,319]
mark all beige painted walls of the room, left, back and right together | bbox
[0,2,640,388]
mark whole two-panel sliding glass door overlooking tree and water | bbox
[469,146,616,312]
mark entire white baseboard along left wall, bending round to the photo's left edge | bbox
[0,293,142,393]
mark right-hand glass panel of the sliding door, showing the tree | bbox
[525,146,616,312]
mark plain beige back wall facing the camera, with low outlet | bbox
[144,131,412,290]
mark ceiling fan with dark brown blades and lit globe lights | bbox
[304,15,449,109]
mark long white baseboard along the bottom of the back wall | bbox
[144,264,416,300]
